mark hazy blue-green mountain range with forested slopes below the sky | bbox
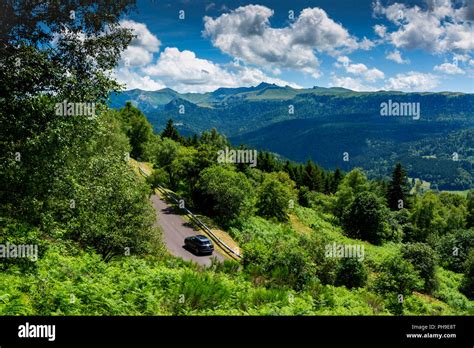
[110,83,474,190]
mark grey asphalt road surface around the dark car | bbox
[151,195,224,266]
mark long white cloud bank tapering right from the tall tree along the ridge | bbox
[113,20,300,92]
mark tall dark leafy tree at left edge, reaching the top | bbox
[0,0,134,223]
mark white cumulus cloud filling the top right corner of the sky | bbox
[374,0,474,53]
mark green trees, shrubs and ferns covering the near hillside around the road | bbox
[0,1,474,315]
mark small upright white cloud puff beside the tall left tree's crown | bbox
[120,20,161,66]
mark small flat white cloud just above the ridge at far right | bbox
[384,71,439,92]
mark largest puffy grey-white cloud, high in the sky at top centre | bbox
[204,5,372,78]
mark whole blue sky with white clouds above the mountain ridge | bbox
[116,0,474,93]
